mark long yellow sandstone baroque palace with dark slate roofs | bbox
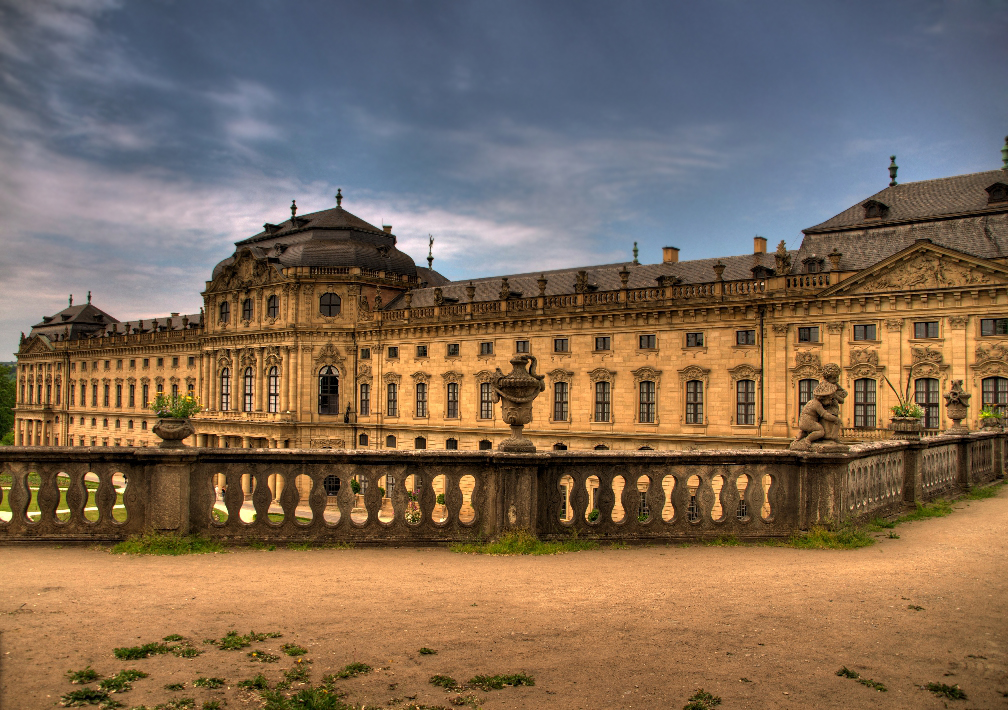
[15,140,1008,450]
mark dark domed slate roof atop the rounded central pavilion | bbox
[212,200,417,278]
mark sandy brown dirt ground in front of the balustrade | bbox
[0,488,1008,710]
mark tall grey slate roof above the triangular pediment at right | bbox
[792,170,1008,273]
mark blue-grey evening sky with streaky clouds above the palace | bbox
[0,0,1008,360]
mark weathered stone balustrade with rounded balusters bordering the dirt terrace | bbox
[0,432,1006,545]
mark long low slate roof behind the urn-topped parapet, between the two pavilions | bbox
[385,251,797,311]
